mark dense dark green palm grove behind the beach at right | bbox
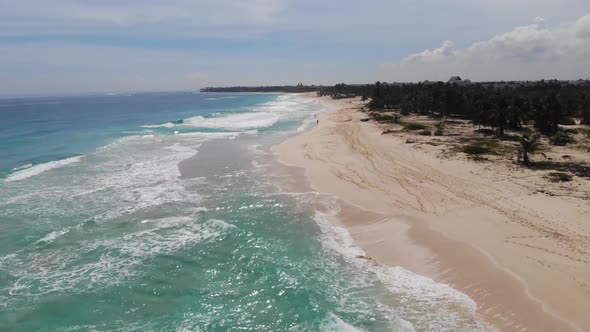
[318,81,590,166]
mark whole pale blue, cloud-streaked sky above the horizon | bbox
[0,0,590,96]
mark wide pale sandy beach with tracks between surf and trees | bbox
[273,96,590,331]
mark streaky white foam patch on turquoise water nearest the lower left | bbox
[0,216,235,307]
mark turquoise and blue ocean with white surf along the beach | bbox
[0,93,481,331]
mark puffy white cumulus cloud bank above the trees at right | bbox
[385,15,590,80]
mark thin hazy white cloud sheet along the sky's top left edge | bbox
[0,0,286,35]
